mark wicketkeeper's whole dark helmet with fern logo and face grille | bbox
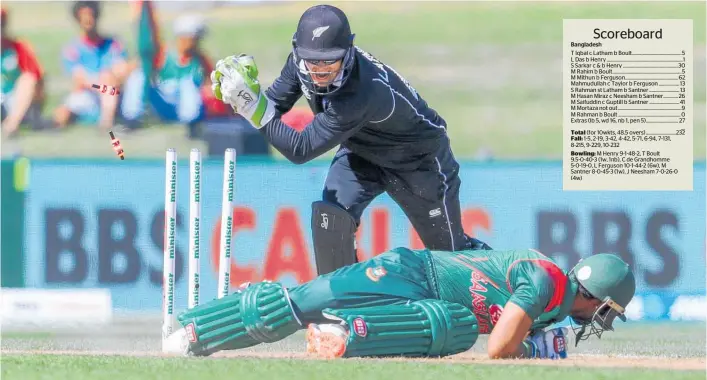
[292,5,356,95]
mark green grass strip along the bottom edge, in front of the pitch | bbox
[2,355,705,380]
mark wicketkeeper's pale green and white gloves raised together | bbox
[211,54,275,128]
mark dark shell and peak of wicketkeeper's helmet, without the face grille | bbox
[294,5,353,60]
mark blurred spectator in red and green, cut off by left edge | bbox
[0,7,46,137]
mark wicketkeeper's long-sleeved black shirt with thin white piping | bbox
[261,49,448,169]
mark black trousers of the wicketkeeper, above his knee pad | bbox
[322,141,471,251]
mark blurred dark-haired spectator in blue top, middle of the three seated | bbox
[54,1,129,128]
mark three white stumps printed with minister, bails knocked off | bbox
[162,149,236,350]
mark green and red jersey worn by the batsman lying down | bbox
[430,250,577,334]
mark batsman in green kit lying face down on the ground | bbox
[164,248,636,359]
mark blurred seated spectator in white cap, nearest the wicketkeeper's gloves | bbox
[121,2,229,138]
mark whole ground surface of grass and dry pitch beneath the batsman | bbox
[2,319,706,380]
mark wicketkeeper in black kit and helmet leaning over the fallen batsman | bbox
[211,5,491,275]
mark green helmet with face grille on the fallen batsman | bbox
[568,253,636,346]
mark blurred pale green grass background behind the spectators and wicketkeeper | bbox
[2,1,705,160]
